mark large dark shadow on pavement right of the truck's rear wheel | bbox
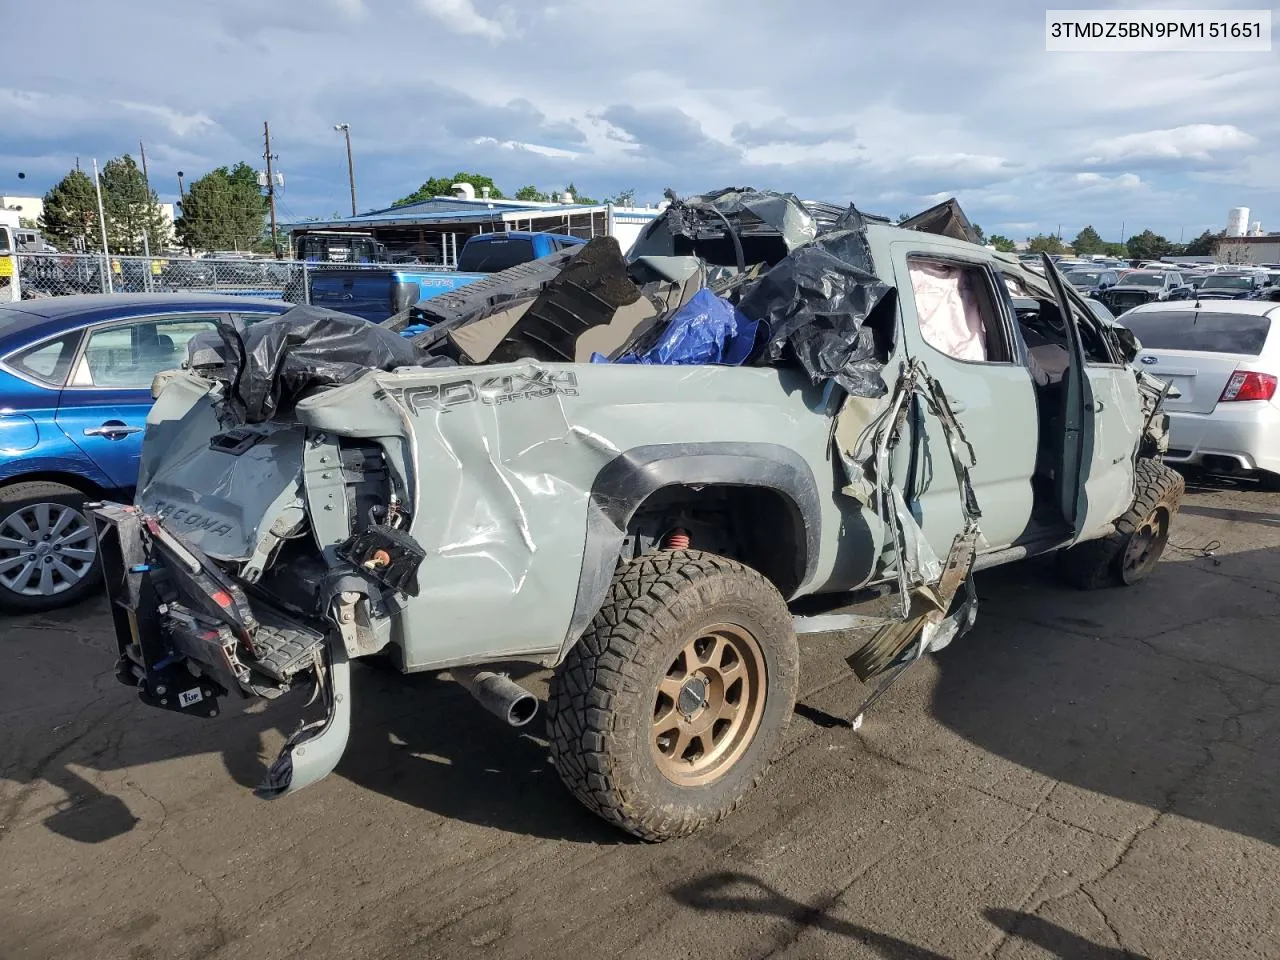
[932,550,1280,844]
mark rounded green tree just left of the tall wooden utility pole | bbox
[175,163,270,251]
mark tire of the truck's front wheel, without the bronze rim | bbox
[1059,460,1187,590]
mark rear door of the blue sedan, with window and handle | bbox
[58,314,219,489]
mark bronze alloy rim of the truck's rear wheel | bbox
[649,623,767,786]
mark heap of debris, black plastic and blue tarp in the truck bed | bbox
[385,188,906,397]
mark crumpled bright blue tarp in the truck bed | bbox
[591,288,760,366]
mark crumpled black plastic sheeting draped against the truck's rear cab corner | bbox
[739,207,893,397]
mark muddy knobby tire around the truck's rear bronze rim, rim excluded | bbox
[547,550,799,841]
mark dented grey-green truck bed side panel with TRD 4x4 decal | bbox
[297,362,835,668]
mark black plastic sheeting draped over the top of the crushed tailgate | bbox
[219,306,422,424]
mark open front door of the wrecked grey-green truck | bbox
[1042,255,1143,538]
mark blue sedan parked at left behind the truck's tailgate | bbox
[0,293,293,612]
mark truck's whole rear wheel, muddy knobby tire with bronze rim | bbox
[547,550,799,841]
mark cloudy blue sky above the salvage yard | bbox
[0,0,1280,241]
